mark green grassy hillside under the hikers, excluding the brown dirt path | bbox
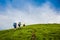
[0,24,60,40]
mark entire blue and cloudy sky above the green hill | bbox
[0,0,60,30]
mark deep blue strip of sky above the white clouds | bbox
[0,0,60,10]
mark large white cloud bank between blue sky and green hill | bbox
[0,2,60,28]
